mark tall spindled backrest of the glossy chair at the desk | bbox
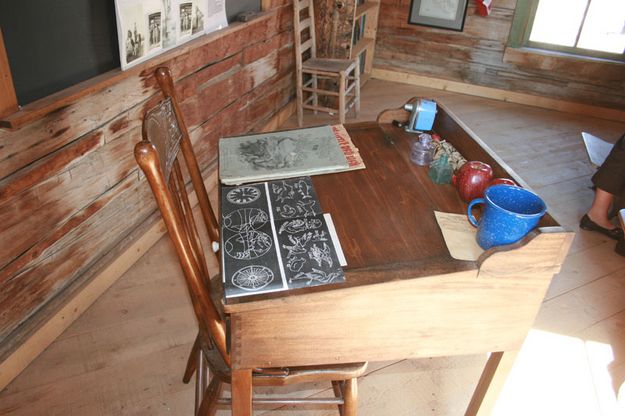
[135,68,230,365]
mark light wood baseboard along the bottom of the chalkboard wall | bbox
[0,101,295,390]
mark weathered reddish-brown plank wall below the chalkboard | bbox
[0,0,294,361]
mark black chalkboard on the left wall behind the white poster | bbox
[0,0,260,105]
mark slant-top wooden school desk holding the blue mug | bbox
[225,104,574,416]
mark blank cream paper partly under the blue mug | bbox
[434,211,484,261]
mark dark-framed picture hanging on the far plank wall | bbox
[408,0,469,32]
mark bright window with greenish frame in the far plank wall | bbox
[509,0,625,61]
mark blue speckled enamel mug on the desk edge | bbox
[467,185,547,250]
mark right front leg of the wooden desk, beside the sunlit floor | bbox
[465,351,518,416]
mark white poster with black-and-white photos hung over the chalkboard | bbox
[115,0,228,70]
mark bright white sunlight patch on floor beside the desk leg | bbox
[494,330,625,416]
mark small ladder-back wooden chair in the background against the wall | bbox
[293,0,360,127]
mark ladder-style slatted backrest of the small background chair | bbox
[293,0,317,68]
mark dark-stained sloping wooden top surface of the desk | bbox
[222,104,557,304]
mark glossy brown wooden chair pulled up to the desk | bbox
[135,68,367,416]
